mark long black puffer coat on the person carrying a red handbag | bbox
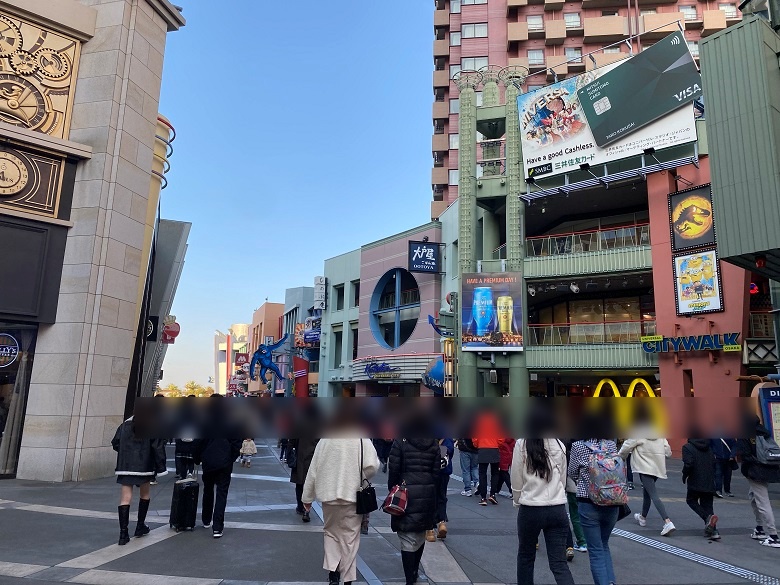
[387,439,440,532]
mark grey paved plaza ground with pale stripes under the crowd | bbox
[0,441,780,585]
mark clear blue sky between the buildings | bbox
[155,0,433,386]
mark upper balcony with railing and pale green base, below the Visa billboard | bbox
[524,224,652,278]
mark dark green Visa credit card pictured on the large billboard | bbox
[577,31,702,147]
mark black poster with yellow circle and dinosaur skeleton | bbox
[669,185,715,252]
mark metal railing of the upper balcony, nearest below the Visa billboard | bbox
[525,224,650,256]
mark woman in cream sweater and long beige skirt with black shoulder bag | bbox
[301,437,379,585]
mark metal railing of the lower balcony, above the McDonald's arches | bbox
[528,319,656,345]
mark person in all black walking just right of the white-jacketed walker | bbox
[682,439,720,540]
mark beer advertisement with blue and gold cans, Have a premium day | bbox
[461,272,523,351]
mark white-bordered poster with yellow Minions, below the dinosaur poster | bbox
[674,250,723,316]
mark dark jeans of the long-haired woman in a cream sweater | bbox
[517,504,574,585]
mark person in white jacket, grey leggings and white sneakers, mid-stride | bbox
[619,438,675,536]
